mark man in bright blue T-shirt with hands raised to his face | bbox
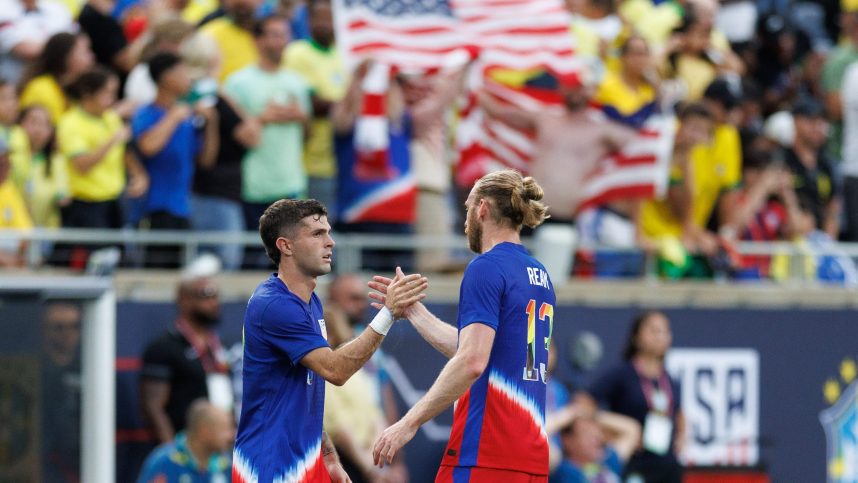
[131,52,219,267]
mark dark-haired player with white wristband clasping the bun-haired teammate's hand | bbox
[233,200,427,483]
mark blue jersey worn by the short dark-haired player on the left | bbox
[232,274,330,483]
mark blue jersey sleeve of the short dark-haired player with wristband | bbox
[260,301,329,365]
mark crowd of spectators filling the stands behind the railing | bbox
[0,0,858,285]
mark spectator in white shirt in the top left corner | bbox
[0,0,77,83]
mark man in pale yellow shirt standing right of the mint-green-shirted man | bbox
[284,0,349,216]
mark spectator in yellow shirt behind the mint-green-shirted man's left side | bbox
[200,0,262,83]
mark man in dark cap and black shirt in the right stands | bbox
[784,99,841,240]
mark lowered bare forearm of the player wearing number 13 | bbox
[403,354,484,427]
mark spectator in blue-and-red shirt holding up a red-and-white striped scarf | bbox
[331,62,417,271]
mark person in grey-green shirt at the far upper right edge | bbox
[822,0,858,163]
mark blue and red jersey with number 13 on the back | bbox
[441,243,555,475]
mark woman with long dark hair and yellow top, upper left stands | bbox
[21,33,95,123]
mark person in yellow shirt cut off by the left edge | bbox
[0,137,33,268]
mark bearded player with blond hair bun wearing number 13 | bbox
[370,170,555,483]
